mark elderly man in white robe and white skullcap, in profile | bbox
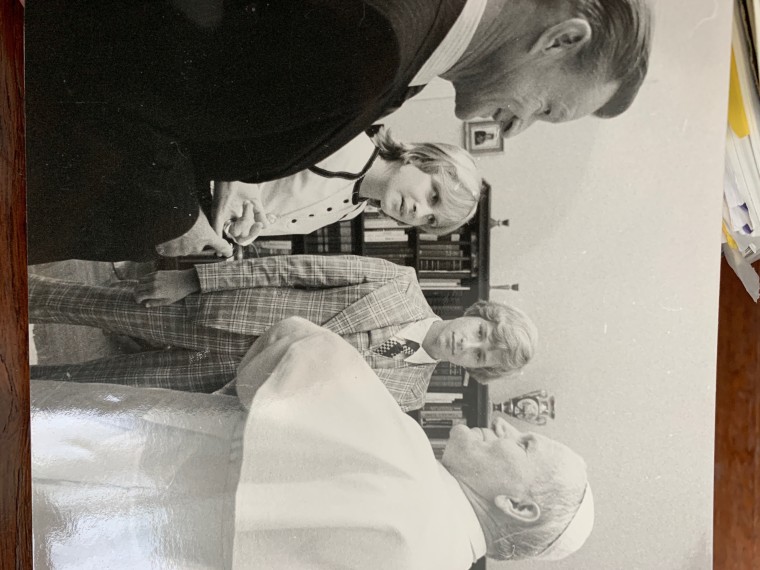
[32,317,594,570]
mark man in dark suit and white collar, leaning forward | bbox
[26,0,651,263]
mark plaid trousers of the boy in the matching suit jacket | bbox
[29,275,256,392]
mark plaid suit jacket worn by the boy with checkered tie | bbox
[185,255,435,411]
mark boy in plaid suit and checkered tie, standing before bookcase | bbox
[29,255,536,410]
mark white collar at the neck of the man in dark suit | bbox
[409,0,487,87]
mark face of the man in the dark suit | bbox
[452,51,618,138]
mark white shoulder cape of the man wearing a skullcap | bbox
[233,323,486,570]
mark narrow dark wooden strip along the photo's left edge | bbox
[0,0,32,569]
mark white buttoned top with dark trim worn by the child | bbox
[215,133,377,237]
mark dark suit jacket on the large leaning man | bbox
[27,0,464,262]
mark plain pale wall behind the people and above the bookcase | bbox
[385,0,731,570]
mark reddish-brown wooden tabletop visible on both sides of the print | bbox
[0,0,760,570]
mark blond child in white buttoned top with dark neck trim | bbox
[214,127,483,245]
